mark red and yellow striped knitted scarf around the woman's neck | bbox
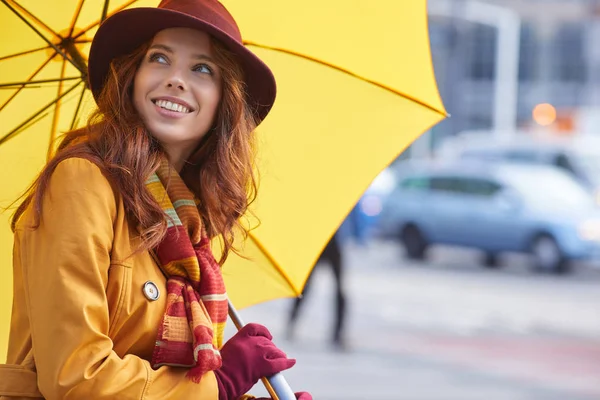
[146,160,227,383]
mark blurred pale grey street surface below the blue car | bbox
[242,242,600,400]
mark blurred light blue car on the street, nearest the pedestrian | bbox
[378,161,600,273]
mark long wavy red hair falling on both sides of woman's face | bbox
[11,36,257,263]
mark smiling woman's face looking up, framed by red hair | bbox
[133,28,221,162]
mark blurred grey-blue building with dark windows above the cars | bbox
[416,0,600,153]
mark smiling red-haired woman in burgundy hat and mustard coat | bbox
[0,0,311,400]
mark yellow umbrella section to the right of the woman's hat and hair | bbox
[211,0,446,307]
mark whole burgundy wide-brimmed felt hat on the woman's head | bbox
[88,0,276,122]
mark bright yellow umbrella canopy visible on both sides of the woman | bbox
[0,0,446,360]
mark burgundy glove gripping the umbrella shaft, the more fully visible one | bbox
[215,324,296,400]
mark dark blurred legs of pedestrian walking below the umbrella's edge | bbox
[287,233,347,350]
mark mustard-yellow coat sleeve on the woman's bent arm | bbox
[16,158,218,400]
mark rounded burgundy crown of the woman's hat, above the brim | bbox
[158,0,242,43]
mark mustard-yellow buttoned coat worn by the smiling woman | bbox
[0,158,218,400]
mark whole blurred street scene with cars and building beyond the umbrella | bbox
[243,0,600,400]
